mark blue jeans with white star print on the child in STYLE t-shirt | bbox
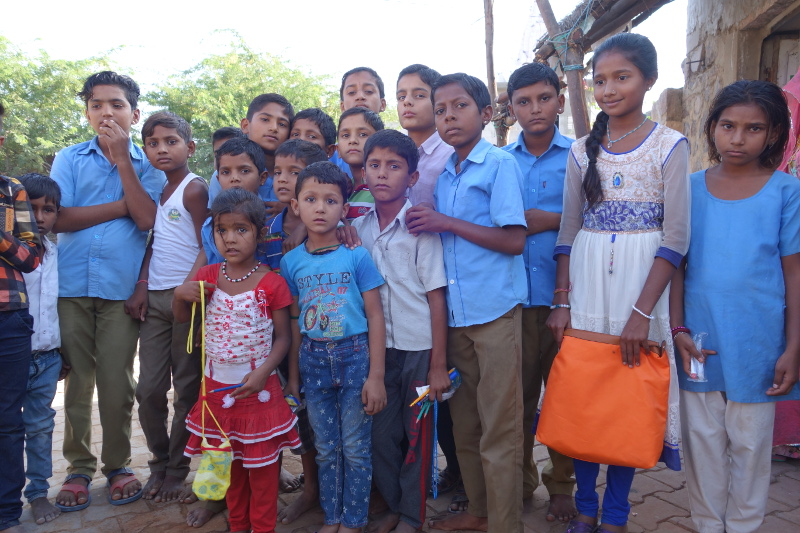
[300,334,372,528]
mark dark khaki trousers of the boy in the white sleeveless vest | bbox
[136,289,201,478]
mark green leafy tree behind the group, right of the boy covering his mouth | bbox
[144,32,340,178]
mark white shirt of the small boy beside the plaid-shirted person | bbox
[22,236,61,352]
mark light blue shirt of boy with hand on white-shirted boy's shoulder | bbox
[434,139,528,327]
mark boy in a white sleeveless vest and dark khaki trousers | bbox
[127,111,208,502]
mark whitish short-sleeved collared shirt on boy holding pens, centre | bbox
[353,200,447,351]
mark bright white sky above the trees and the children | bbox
[0,0,688,111]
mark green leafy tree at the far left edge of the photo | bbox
[0,36,108,176]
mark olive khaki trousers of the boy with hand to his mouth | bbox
[58,298,139,477]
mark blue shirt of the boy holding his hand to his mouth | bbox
[50,137,167,300]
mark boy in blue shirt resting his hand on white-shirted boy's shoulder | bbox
[406,74,528,533]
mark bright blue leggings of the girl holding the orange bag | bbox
[574,459,636,526]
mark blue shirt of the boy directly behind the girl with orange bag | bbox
[503,126,575,307]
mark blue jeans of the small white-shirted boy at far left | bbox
[22,350,61,502]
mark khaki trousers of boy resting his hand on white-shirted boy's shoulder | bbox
[447,305,523,533]
